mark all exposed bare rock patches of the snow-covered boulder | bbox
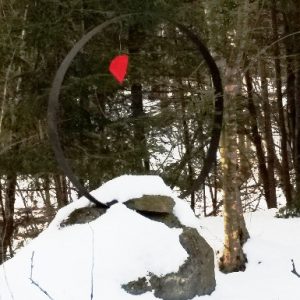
[61,195,216,300]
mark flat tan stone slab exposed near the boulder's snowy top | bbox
[124,195,175,213]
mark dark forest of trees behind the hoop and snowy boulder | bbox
[0,0,300,272]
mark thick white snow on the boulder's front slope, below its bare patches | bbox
[0,203,187,300]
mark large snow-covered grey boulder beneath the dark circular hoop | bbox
[0,176,215,300]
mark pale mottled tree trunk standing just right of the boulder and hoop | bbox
[220,2,249,273]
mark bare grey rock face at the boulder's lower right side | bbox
[122,227,216,300]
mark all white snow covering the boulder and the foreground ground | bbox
[0,176,300,300]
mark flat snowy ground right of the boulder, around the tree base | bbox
[199,209,300,300]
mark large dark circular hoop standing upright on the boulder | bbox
[47,14,223,208]
